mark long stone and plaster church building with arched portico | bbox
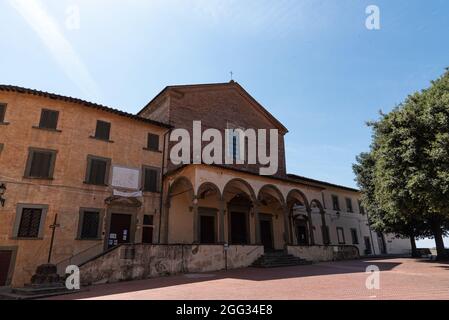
[0,81,409,287]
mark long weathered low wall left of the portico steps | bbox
[80,244,263,284]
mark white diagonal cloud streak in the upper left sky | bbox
[9,0,99,99]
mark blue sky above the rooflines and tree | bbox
[0,0,449,246]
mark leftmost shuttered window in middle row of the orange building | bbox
[25,148,56,179]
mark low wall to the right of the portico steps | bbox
[287,245,360,262]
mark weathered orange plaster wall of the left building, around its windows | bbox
[0,92,166,287]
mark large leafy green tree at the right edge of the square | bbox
[354,71,449,259]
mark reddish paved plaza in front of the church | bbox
[47,258,449,300]
